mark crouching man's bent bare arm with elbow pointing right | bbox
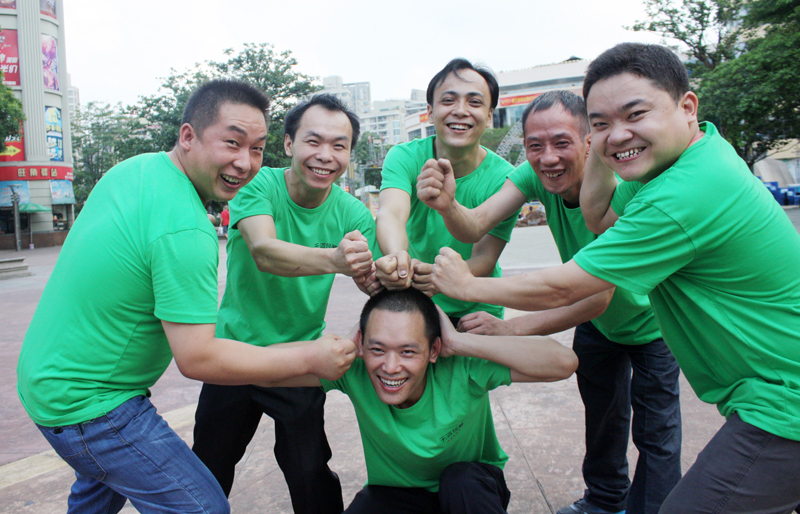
[439,309,578,382]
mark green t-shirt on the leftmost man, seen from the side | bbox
[17,152,219,426]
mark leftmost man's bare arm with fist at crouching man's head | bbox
[161,321,356,386]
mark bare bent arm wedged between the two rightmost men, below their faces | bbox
[580,149,619,234]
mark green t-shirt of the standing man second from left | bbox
[217,168,378,346]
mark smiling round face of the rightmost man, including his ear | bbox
[586,73,698,182]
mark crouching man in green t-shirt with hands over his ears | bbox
[260,288,578,514]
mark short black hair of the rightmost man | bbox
[583,43,690,102]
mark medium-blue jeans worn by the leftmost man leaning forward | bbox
[37,396,230,514]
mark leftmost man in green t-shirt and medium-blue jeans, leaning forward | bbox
[17,80,355,514]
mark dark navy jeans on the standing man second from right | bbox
[572,322,681,514]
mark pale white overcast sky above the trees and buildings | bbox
[63,0,660,105]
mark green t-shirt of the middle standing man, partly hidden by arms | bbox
[381,136,518,318]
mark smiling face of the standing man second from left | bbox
[283,105,353,205]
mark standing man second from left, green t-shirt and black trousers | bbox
[192,94,380,514]
